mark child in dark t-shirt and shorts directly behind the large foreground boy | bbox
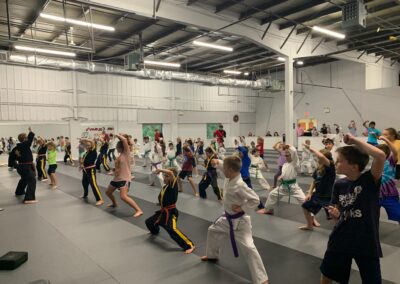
[299,144,336,231]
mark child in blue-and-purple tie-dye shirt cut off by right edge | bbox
[377,136,400,223]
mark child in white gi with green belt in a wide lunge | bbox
[257,146,306,215]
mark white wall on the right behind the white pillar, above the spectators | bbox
[257,61,400,133]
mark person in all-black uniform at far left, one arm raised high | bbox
[10,127,38,204]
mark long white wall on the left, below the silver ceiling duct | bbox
[0,65,256,139]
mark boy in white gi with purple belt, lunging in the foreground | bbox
[201,156,268,284]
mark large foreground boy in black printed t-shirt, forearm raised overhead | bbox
[320,134,386,284]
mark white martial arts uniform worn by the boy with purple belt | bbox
[206,172,268,284]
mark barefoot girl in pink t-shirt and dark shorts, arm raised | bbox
[106,134,143,218]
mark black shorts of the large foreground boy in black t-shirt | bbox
[320,251,382,284]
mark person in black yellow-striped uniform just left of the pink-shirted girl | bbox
[80,138,104,206]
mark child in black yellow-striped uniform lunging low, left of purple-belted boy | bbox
[146,168,195,254]
